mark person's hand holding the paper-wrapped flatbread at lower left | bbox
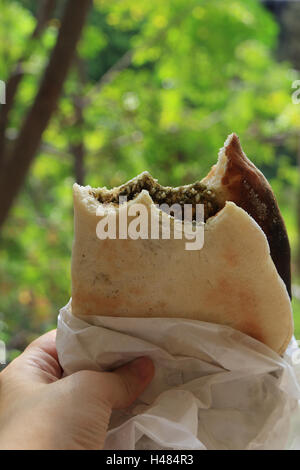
[0,331,154,449]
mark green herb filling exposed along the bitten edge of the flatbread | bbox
[93,172,221,220]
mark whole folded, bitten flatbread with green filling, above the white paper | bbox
[72,134,293,354]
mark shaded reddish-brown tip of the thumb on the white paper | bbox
[101,357,155,409]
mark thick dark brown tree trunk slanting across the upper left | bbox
[0,0,92,228]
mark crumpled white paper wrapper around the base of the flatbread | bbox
[57,303,300,450]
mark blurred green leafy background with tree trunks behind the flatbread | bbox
[0,0,300,359]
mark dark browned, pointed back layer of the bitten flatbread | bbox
[202,134,292,298]
